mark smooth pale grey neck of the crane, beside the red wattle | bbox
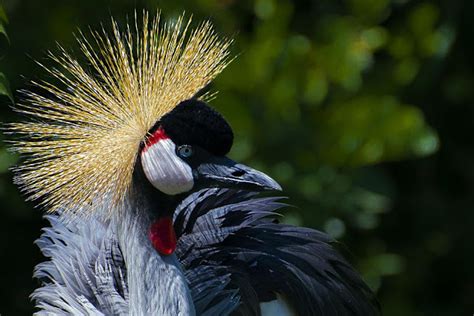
[116,196,195,315]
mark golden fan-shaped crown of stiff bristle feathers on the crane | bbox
[7,12,231,217]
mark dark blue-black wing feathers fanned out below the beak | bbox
[175,189,380,315]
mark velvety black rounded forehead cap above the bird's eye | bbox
[159,99,234,156]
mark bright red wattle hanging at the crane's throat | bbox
[148,216,176,256]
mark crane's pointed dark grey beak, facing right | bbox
[195,157,281,191]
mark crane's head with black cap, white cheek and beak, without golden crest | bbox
[140,99,281,196]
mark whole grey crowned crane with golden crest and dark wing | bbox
[6,11,380,316]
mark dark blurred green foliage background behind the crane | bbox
[0,0,474,316]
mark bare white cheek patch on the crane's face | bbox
[141,138,194,195]
